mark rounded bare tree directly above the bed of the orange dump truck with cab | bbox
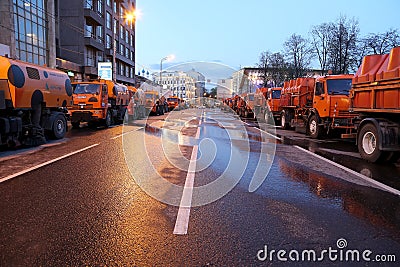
[284,34,312,78]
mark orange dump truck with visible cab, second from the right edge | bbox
[280,74,355,138]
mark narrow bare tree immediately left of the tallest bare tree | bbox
[310,22,334,75]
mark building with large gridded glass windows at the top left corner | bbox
[0,0,56,67]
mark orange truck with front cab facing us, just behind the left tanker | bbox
[69,79,130,128]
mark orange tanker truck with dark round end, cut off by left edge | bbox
[0,56,72,147]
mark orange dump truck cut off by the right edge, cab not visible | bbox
[350,47,400,162]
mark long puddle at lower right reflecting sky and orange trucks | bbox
[250,157,400,242]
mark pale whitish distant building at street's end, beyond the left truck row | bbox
[153,71,197,99]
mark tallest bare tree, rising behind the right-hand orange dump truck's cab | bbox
[328,16,360,74]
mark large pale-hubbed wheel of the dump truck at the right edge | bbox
[357,123,385,162]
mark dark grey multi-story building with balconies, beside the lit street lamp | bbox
[56,0,136,84]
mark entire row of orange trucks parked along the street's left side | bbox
[0,56,184,147]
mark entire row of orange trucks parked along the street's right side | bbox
[224,47,400,162]
